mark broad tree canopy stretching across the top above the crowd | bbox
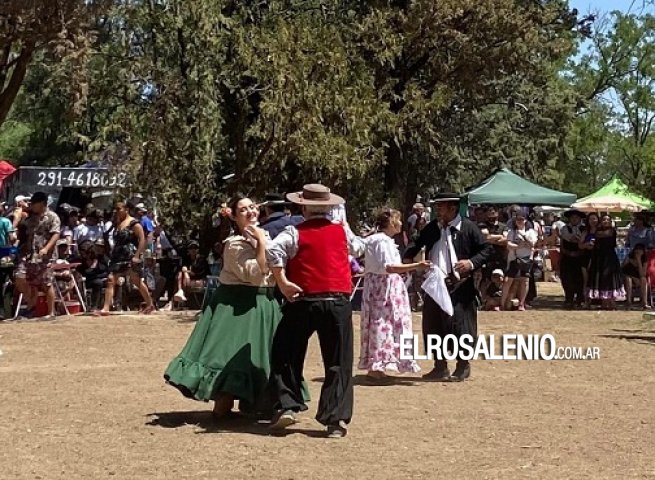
[0,0,654,232]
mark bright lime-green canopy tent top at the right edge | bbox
[573,175,655,212]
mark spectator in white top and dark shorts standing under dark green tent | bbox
[501,211,538,311]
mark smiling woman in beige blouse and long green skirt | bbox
[164,196,281,417]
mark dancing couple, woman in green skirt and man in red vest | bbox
[164,184,364,438]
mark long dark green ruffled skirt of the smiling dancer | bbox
[164,285,282,411]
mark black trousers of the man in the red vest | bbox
[271,297,353,425]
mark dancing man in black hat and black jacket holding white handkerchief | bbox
[403,193,493,381]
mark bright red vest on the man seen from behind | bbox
[287,218,352,295]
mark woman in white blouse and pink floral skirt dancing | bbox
[358,209,430,379]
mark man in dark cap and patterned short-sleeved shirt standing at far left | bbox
[15,192,61,316]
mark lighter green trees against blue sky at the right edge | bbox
[568,5,655,196]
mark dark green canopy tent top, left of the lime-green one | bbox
[464,168,576,207]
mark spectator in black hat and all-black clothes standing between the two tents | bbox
[559,210,585,308]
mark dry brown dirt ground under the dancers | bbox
[0,284,655,479]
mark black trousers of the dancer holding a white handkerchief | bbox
[423,295,478,367]
